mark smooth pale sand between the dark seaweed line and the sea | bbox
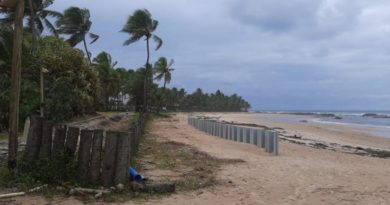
[206,113,390,154]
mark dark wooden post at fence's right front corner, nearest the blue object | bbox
[114,132,131,185]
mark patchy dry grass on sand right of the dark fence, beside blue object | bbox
[136,137,242,191]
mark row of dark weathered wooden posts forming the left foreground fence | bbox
[25,115,144,187]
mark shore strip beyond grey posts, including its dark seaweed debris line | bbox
[197,113,390,158]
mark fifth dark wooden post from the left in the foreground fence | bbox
[77,130,93,182]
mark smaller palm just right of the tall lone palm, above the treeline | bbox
[154,57,175,112]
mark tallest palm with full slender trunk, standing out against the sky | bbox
[122,9,163,112]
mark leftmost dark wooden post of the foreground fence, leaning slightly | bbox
[25,116,43,161]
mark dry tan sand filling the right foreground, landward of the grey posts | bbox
[6,114,390,205]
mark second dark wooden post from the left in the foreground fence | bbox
[39,121,53,159]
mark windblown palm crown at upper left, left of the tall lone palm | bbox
[56,7,99,63]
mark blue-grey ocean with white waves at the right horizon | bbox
[253,111,390,138]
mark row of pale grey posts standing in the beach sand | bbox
[188,116,279,155]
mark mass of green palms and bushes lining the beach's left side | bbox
[0,0,250,175]
